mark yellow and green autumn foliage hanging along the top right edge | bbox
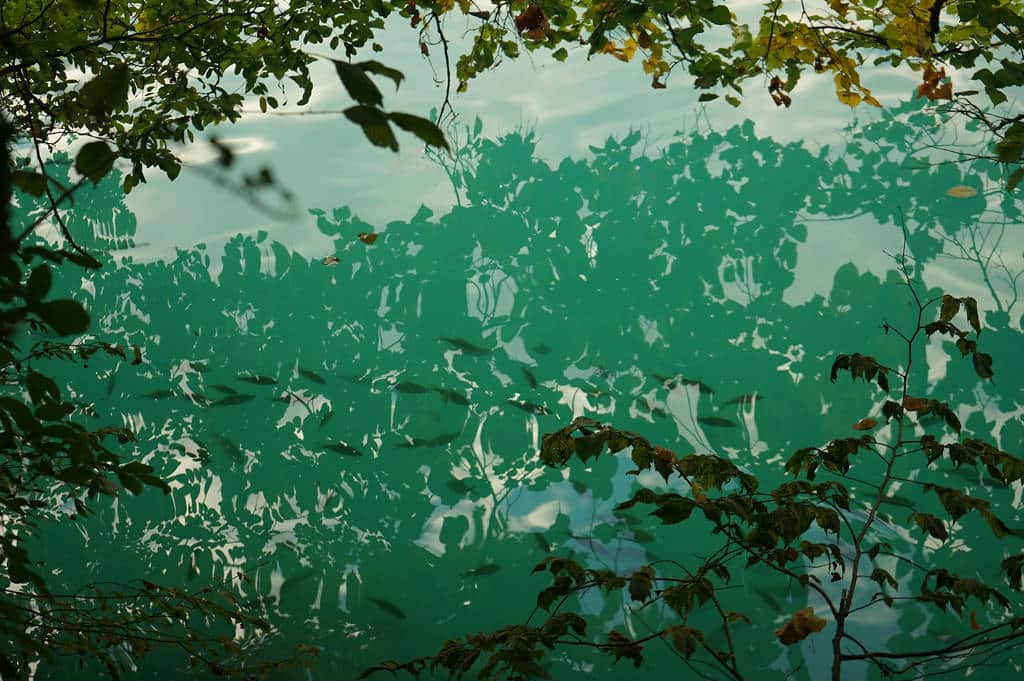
[411,0,1024,178]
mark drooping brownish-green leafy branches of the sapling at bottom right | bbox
[382,256,1024,681]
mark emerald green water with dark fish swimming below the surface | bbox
[12,94,1024,679]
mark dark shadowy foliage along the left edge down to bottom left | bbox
[0,127,315,678]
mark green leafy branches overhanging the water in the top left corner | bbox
[0,0,445,238]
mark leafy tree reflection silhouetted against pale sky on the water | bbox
[22,96,1024,678]
